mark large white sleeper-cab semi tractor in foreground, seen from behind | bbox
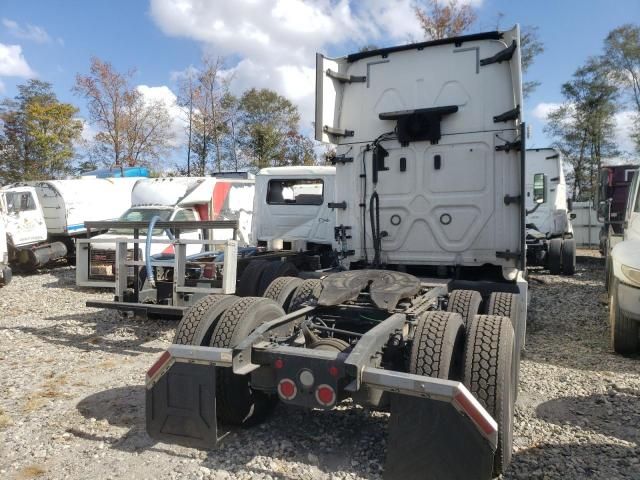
[146,27,527,479]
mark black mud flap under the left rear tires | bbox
[146,362,218,448]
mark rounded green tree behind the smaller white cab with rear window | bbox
[238,88,300,169]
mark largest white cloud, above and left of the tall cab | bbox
[151,0,432,127]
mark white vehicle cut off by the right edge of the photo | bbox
[607,169,640,354]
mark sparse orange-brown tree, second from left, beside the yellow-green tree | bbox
[73,57,172,166]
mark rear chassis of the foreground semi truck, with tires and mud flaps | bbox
[146,270,522,479]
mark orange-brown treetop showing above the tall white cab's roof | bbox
[413,0,477,40]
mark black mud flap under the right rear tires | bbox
[384,394,494,480]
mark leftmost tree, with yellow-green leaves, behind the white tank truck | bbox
[0,80,82,183]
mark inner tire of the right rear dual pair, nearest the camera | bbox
[409,312,464,380]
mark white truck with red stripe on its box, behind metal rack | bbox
[76,177,254,288]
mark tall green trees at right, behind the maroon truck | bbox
[545,24,640,200]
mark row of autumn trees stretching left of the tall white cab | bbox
[0,57,317,184]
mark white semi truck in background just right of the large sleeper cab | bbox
[525,148,576,275]
